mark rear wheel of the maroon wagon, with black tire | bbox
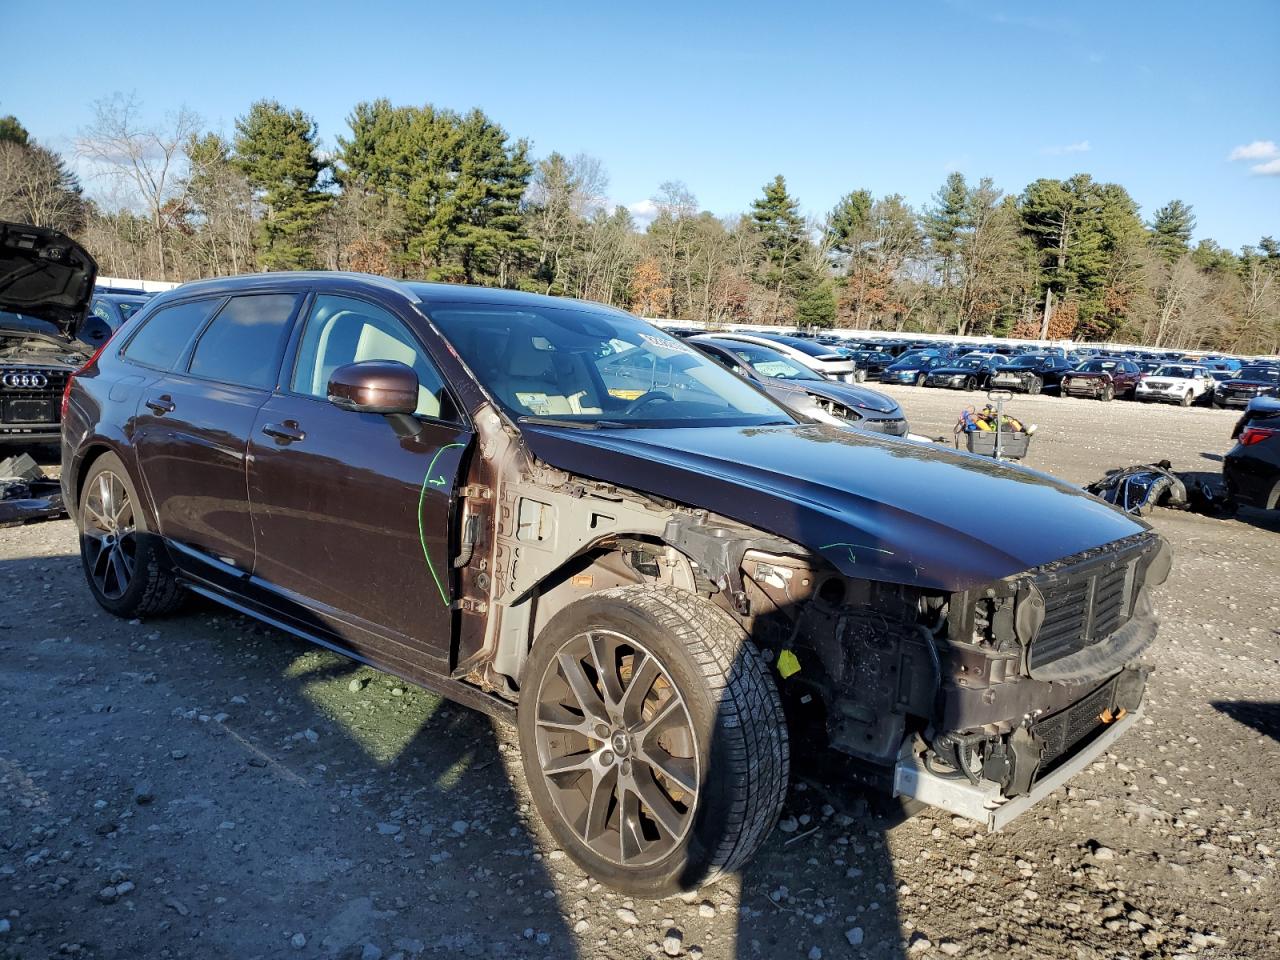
[76,453,187,620]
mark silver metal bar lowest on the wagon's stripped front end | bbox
[893,709,1142,831]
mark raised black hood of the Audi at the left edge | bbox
[0,221,97,340]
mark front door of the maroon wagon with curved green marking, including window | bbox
[248,292,472,673]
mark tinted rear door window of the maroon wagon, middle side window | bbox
[188,293,300,389]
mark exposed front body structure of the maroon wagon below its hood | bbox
[454,407,1171,826]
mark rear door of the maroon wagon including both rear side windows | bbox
[123,292,302,581]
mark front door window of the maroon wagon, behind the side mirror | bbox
[289,293,456,420]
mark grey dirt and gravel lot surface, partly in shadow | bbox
[0,388,1280,960]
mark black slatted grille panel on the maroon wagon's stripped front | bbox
[1028,537,1142,672]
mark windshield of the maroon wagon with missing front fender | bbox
[426,303,795,426]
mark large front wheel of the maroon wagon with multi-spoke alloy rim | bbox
[518,585,788,897]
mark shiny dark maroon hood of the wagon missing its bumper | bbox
[524,424,1148,590]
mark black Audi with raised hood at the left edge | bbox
[0,221,110,444]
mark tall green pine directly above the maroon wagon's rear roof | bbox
[236,100,330,270]
